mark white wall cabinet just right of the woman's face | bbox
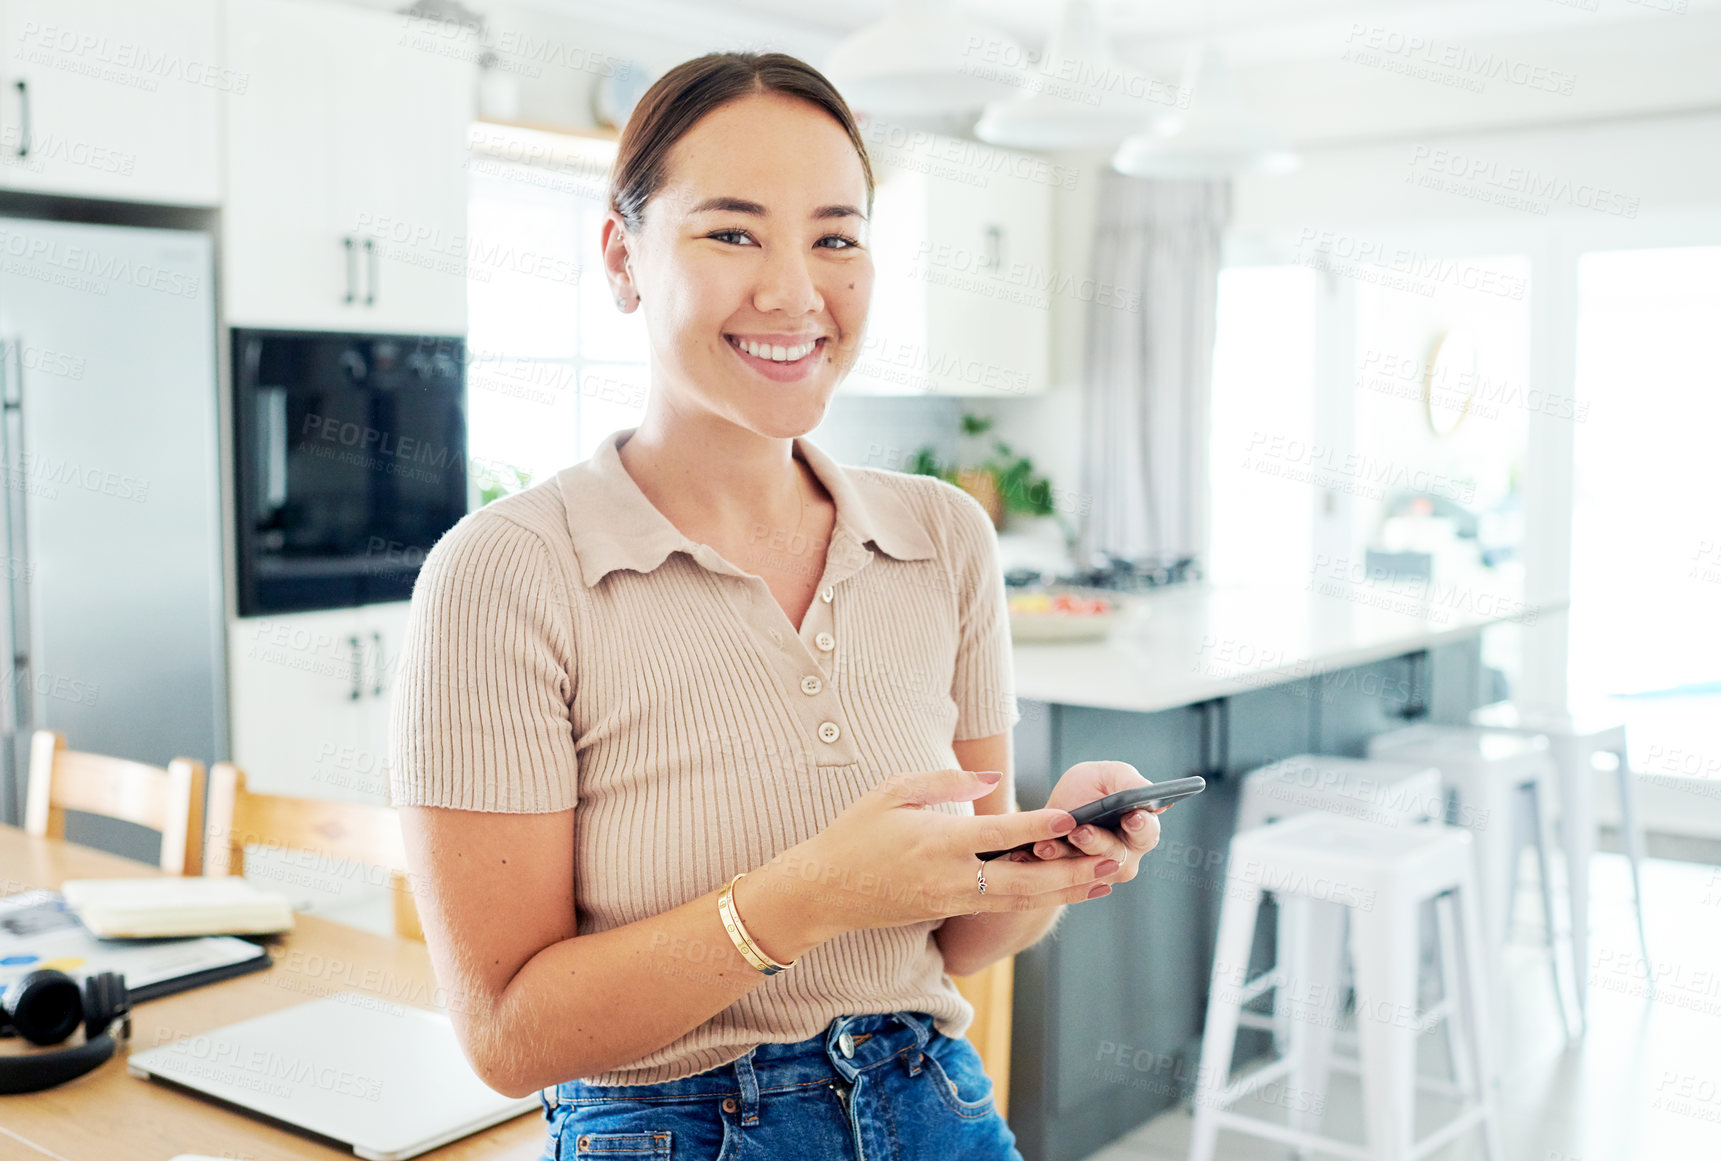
[843,134,1072,399]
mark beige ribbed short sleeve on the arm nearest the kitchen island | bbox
[948,485,1022,741]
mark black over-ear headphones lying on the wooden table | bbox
[0,968,131,1094]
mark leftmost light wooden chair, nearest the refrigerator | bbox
[24,729,203,875]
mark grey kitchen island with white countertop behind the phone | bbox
[1010,578,1558,1161]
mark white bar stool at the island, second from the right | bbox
[1368,722,1583,1037]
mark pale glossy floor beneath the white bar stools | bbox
[1088,855,1721,1161]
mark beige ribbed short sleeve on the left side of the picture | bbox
[389,509,578,814]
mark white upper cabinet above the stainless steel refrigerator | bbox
[0,0,222,206]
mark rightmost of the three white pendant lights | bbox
[1112,43,1301,177]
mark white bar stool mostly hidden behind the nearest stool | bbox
[1236,753,1446,1051]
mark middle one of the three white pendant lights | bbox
[974,0,1174,150]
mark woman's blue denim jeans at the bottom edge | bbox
[539,1011,1022,1161]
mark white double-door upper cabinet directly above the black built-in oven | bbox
[225,0,475,334]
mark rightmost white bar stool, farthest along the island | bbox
[1470,702,1654,1011]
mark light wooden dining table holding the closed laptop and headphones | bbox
[0,824,547,1161]
